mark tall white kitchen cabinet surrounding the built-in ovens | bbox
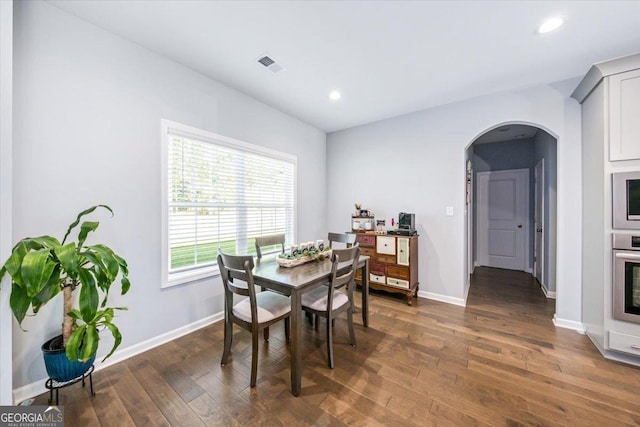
[571,54,640,365]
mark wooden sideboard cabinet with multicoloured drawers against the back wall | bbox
[356,233,419,305]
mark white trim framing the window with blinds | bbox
[160,119,298,289]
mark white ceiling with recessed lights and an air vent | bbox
[50,0,640,132]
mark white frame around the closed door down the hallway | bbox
[475,169,532,273]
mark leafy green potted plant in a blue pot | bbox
[0,205,130,382]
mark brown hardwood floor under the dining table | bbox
[34,268,640,426]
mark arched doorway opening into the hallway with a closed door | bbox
[465,122,557,298]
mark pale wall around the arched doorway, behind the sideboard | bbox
[327,79,581,320]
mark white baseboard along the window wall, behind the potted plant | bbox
[13,312,224,405]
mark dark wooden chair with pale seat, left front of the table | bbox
[218,251,291,387]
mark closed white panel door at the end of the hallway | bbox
[477,169,530,271]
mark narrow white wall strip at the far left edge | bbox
[0,1,13,406]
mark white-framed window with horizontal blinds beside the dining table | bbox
[162,120,296,287]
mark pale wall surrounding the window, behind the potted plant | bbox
[12,1,326,400]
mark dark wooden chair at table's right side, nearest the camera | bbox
[302,245,360,369]
